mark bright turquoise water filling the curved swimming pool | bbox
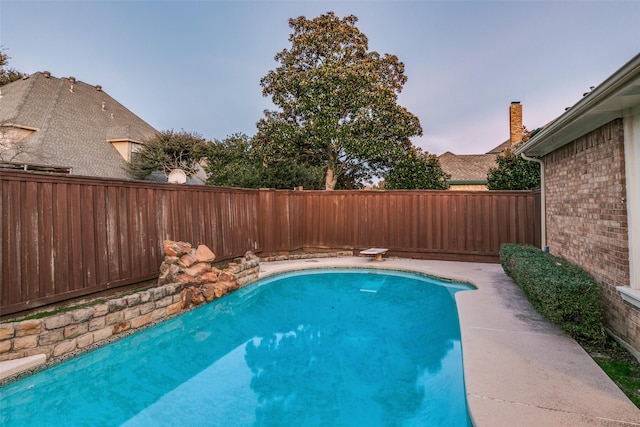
[0,270,470,427]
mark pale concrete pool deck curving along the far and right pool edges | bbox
[260,257,640,427]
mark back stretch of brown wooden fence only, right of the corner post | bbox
[260,190,540,262]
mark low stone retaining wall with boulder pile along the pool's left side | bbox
[0,241,260,368]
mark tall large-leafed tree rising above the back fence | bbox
[258,12,422,190]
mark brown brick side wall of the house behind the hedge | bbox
[544,119,640,351]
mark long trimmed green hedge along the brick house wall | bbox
[500,244,606,345]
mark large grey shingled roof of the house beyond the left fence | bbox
[0,72,157,179]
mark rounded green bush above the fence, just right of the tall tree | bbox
[384,147,450,190]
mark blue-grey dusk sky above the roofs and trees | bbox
[0,0,640,154]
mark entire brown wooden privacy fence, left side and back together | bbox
[0,172,540,316]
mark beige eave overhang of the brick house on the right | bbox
[516,54,640,157]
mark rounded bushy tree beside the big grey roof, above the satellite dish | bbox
[129,130,206,179]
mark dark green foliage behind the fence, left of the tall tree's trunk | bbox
[205,134,322,189]
